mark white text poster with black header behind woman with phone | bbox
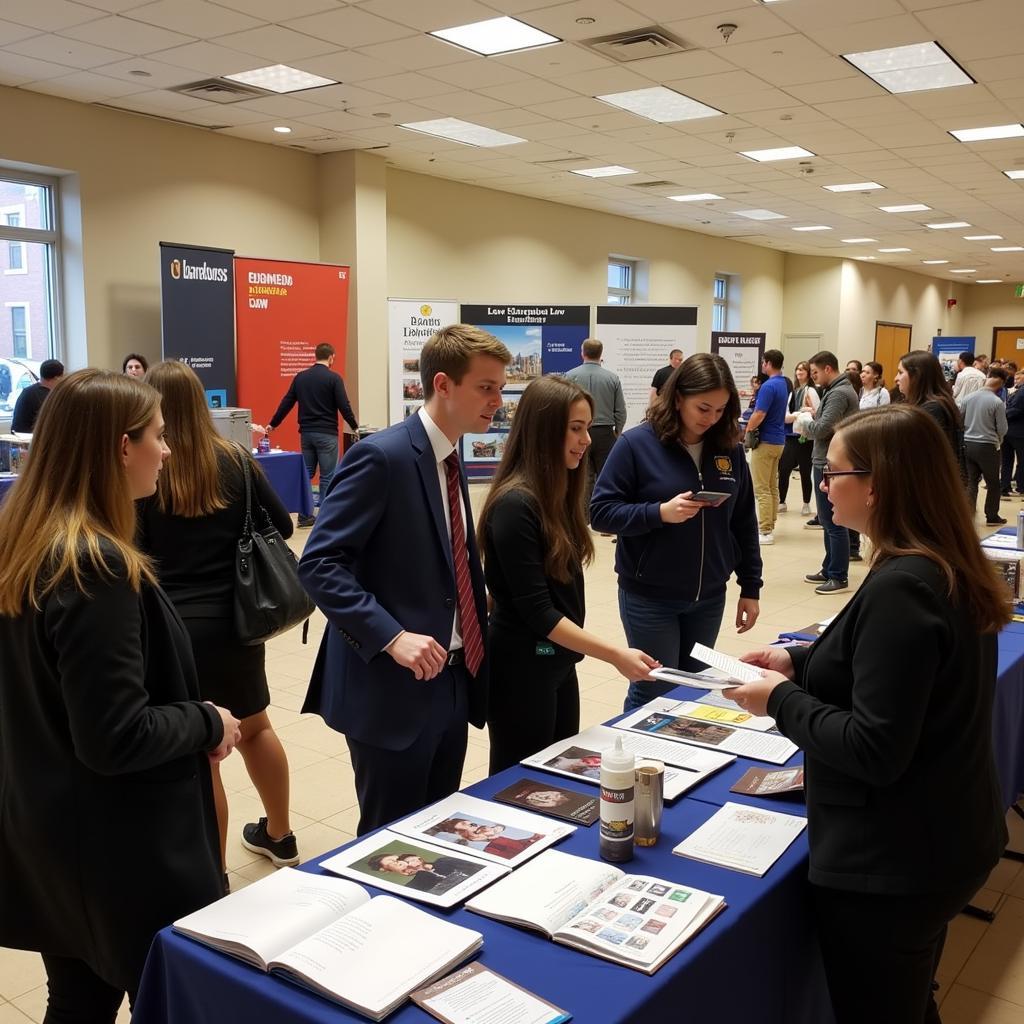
[594,306,697,428]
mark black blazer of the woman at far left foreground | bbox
[0,549,223,989]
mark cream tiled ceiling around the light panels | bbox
[0,0,1024,282]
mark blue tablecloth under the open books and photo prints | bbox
[132,689,833,1024]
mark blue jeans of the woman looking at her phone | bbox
[618,587,725,711]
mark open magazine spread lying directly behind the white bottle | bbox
[519,725,736,800]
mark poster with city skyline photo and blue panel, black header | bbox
[459,302,590,479]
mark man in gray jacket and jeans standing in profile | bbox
[794,351,860,594]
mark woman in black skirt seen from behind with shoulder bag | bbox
[139,360,299,869]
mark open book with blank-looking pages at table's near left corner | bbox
[174,867,483,1021]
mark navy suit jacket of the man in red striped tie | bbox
[299,416,487,751]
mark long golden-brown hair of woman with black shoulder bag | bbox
[145,359,240,518]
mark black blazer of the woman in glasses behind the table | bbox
[768,556,1007,894]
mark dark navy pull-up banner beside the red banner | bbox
[160,242,234,409]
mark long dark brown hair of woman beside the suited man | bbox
[478,375,594,583]
